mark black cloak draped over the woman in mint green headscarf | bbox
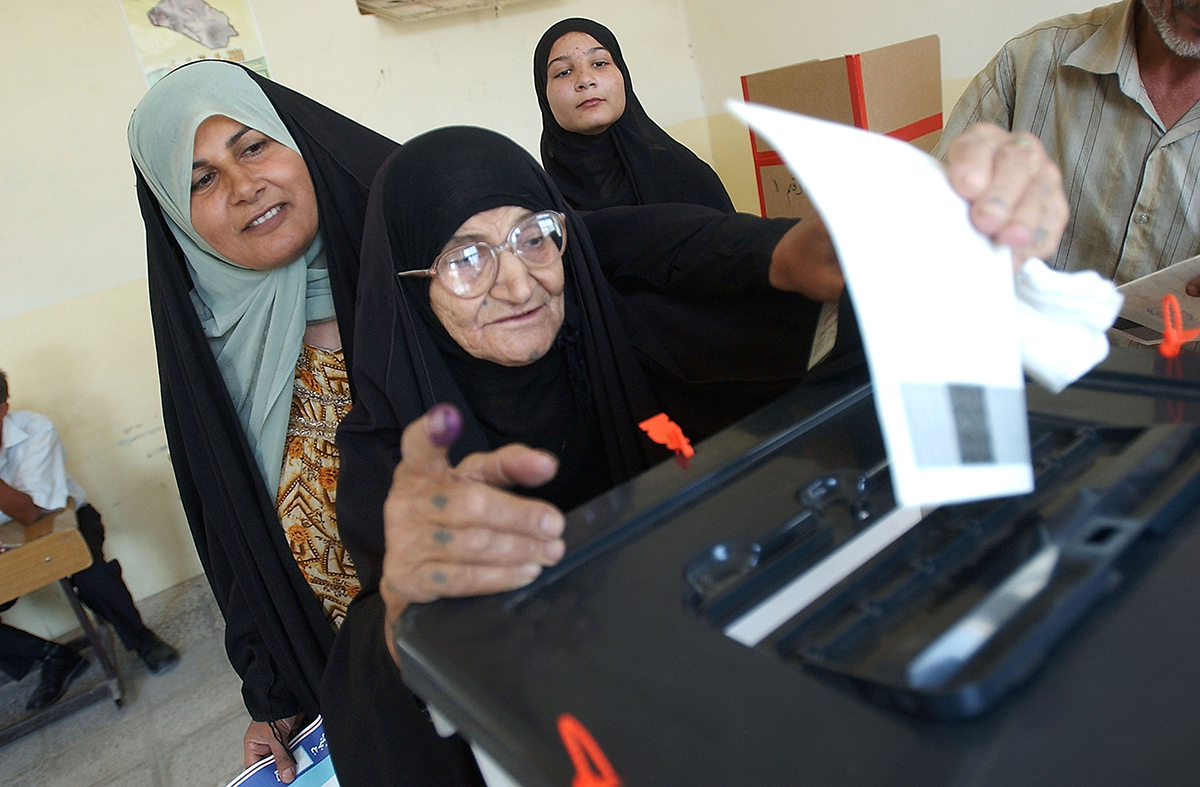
[134,64,397,721]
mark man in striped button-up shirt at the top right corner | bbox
[936,0,1200,289]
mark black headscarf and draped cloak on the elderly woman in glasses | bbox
[322,128,667,787]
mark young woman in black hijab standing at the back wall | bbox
[533,19,733,212]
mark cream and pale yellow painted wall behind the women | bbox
[0,0,1089,635]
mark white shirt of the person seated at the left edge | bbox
[0,410,88,524]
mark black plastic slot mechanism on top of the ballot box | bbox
[762,419,1200,717]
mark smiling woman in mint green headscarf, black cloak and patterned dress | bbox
[128,61,473,782]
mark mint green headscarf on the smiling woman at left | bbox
[128,61,334,495]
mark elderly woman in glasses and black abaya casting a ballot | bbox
[322,118,1062,785]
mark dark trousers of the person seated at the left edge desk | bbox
[0,505,150,680]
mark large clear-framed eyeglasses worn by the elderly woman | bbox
[396,210,566,298]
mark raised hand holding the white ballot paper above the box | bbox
[946,124,1068,265]
